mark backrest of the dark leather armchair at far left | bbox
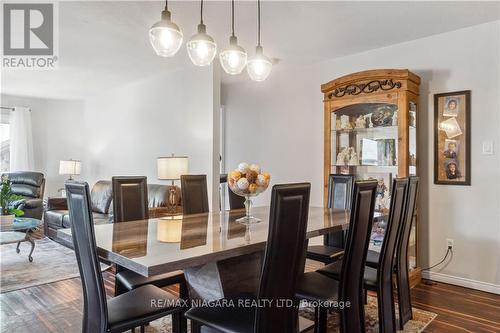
[2,171,45,199]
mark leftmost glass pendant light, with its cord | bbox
[149,0,183,57]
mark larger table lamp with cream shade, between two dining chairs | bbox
[157,154,188,213]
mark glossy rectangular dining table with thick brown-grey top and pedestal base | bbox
[58,207,349,300]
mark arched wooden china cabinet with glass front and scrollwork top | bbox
[321,69,421,286]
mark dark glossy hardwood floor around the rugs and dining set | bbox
[0,232,500,333]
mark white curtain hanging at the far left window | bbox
[9,107,35,172]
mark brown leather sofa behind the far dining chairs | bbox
[44,180,182,245]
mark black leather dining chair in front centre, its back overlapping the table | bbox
[186,183,311,333]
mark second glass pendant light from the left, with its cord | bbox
[187,0,217,66]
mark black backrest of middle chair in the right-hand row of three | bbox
[377,178,408,284]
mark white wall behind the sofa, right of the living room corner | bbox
[82,66,220,207]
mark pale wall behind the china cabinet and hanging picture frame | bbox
[222,21,500,293]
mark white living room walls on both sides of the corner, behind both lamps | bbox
[1,66,220,207]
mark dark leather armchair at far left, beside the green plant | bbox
[2,171,45,220]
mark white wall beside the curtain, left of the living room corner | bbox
[1,95,84,197]
